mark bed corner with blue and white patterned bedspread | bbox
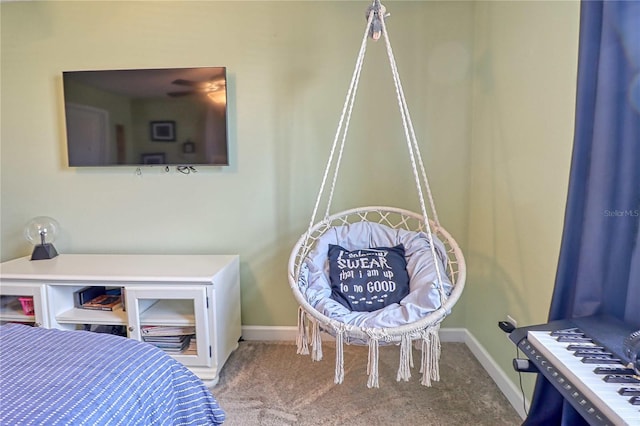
[0,324,225,425]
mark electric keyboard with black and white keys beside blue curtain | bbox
[509,317,640,426]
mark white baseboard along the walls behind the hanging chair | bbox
[242,325,529,419]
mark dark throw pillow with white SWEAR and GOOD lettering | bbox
[329,244,409,312]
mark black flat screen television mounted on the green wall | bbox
[62,67,229,167]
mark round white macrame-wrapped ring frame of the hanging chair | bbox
[289,206,466,344]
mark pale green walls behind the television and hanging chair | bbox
[0,1,579,402]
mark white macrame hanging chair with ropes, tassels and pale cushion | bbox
[288,0,466,387]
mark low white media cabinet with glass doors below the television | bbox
[0,254,241,385]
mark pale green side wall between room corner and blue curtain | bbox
[465,2,579,396]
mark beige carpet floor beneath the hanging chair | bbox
[212,342,522,426]
